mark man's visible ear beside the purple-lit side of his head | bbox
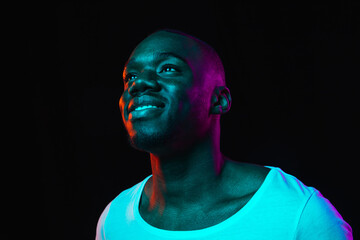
[210,86,231,114]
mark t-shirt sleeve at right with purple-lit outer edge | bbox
[296,190,353,240]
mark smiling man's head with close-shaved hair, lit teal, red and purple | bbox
[119,30,231,154]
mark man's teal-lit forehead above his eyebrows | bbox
[128,32,200,67]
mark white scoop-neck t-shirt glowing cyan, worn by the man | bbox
[96,167,353,240]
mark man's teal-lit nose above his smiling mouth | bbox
[128,71,160,97]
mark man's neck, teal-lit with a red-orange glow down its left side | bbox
[145,125,224,212]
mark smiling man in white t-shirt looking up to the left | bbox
[96,30,352,240]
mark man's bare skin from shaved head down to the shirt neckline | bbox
[119,31,269,230]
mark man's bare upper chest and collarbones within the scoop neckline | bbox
[139,159,269,231]
